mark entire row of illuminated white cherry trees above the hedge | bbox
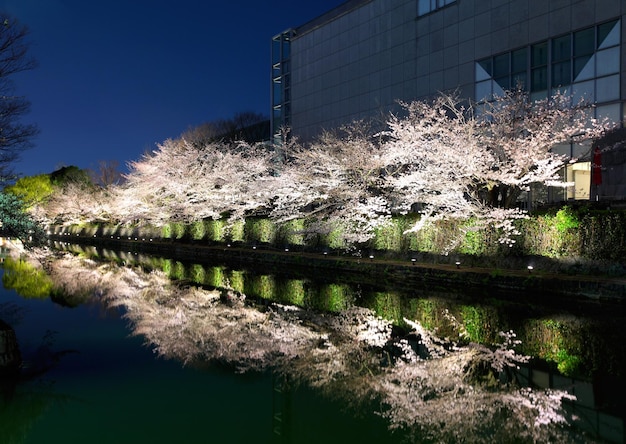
[28,90,608,248]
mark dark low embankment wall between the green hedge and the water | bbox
[50,230,626,301]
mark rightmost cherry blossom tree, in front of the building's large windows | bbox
[478,89,613,208]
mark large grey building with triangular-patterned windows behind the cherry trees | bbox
[272,0,626,199]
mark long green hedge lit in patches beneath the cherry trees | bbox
[54,206,626,263]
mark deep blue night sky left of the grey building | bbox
[0,0,344,175]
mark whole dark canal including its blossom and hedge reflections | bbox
[0,244,626,443]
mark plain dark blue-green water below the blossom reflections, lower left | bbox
[0,278,400,444]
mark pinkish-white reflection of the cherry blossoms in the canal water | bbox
[37,250,589,442]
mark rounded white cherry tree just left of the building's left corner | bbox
[117,139,273,224]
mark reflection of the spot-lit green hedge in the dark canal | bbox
[55,239,626,380]
